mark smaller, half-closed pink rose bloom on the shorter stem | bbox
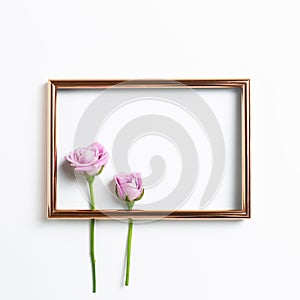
[115,173,144,201]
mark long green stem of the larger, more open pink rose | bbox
[87,176,96,293]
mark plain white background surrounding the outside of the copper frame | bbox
[0,0,300,300]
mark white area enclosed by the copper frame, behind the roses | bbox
[56,88,241,210]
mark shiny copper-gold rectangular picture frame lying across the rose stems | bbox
[47,79,251,220]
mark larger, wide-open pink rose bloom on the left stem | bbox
[65,142,109,176]
